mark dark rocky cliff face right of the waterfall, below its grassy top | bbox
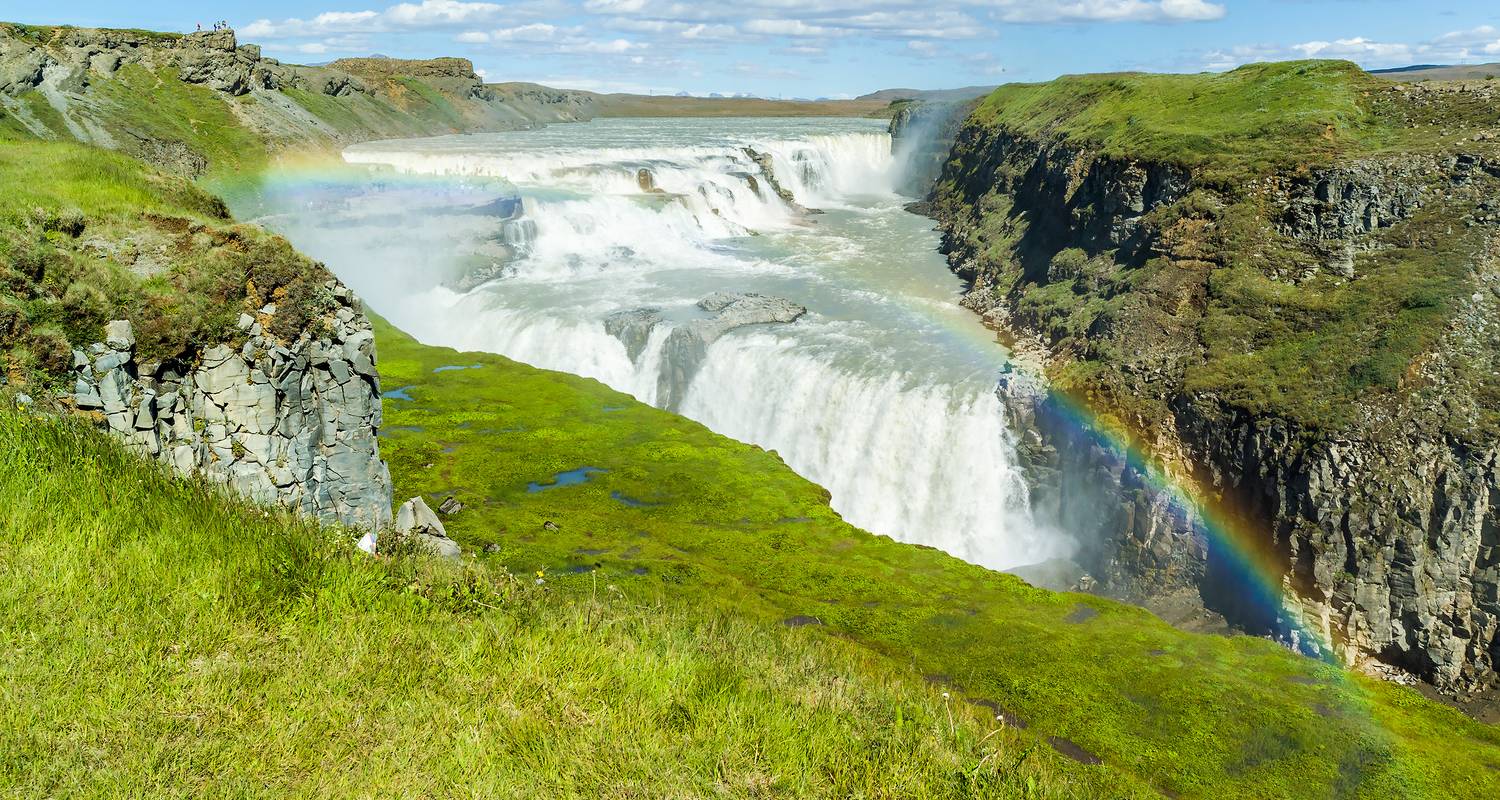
[912,65,1500,692]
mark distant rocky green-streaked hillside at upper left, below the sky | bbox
[0,24,593,176]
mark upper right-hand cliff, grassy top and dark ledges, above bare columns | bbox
[935,62,1500,441]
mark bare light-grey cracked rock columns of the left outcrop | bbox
[72,281,392,528]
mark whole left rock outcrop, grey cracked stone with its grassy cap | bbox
[0,141,392,528]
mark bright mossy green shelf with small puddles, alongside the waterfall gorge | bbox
[369,315,1500,797]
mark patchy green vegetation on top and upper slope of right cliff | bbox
[939,62,1500,431]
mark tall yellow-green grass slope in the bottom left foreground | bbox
[0,410,1113,798]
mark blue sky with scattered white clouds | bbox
[0,0,1500,98]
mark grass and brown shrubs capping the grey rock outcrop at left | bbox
[0,141,340,384]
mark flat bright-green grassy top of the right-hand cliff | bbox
[971,62,1493,186]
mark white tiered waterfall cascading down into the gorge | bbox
[258,120,1070,567]
